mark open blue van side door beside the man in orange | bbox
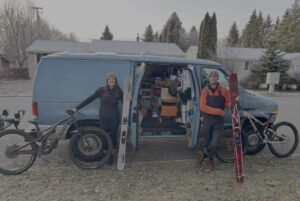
[183,65,201,149]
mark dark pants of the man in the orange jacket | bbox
[203,119,224,159]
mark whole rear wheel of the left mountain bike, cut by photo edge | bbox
[0,129,38,175]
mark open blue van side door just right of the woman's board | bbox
[130,63,146,149]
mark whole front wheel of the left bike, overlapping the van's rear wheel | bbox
[68,127,112,169]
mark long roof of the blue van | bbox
[43,52,221,66]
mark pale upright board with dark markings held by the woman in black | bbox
[118,77,132,170]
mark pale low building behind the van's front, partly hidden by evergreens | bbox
[186,46,300,80]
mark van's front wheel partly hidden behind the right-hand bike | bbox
[245,130,266,155]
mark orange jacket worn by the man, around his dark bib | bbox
[200,84,231,116]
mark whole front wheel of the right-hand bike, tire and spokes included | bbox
[268,121,299,158]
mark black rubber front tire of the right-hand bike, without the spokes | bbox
[268,121,299,158]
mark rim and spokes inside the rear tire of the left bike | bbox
[0,134,35,172]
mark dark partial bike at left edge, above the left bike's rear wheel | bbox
[0,110,25,131]
